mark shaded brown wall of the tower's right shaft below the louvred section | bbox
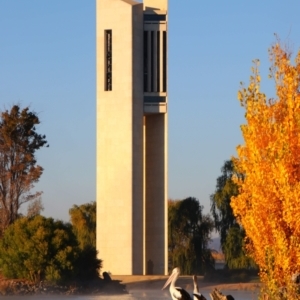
[145,114,168,274]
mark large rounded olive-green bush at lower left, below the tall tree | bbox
[0,215,80,282]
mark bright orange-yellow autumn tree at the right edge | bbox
[231,43,300,300]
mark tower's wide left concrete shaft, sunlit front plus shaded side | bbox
[96,0,143,275]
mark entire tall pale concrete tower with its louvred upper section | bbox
[96,0,168,275]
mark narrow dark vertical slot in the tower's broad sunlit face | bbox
[104,30,112,91]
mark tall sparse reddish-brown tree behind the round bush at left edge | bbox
[0,105,48,234]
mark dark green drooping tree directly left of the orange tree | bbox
[210,160,255,269]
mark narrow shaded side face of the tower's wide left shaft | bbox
[132,4,144,274]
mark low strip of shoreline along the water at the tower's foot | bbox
[0,275,261,296]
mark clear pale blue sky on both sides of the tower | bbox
[0,0,300,221]
